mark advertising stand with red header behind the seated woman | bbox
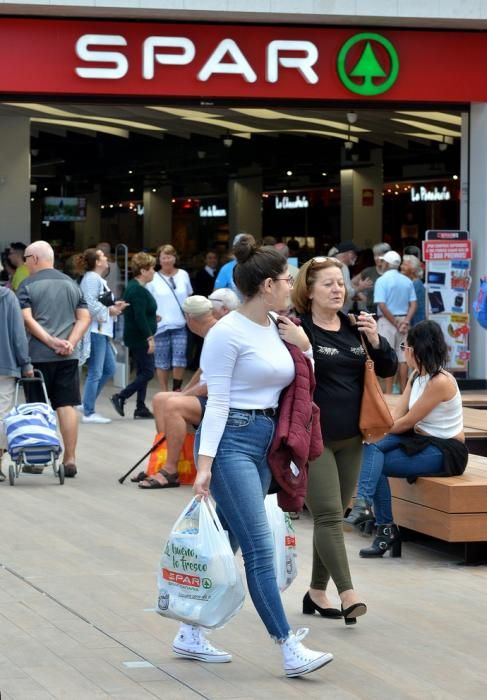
[423,231,472,372]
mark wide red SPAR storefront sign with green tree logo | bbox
[0,17,487,104]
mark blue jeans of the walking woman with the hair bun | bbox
[195,408,290,640]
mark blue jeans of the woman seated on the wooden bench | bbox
[357,435,444,525]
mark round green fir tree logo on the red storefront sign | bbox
[337,32,399,96]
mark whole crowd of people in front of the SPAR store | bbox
[0,234,467,677]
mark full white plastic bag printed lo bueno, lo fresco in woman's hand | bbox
[157,498,245,629]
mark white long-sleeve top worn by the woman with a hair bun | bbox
[199,311,295,457]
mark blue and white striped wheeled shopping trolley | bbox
[4,369,64,486]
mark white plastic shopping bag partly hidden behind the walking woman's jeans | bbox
[265,494,298,591]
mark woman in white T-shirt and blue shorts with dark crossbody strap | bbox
[146,245,193,391]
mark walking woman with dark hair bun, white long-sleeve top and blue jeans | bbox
[173,236,333,676]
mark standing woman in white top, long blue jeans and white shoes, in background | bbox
[78,248,127,423]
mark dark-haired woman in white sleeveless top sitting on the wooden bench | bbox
[346,321,468,557]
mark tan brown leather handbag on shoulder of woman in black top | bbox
[359,337,394,442]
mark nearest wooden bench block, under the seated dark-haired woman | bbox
[389,454,487,563]
